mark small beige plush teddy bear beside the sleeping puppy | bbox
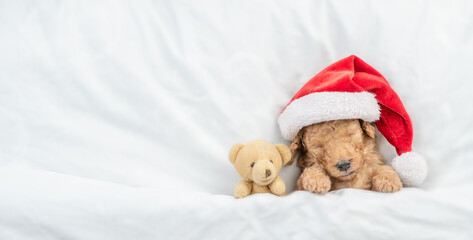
[228,140,291,198]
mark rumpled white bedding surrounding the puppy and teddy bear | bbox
[0,0,473,239]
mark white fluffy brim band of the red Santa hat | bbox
[278,92,380,141]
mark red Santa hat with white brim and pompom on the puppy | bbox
[278,55,427,186]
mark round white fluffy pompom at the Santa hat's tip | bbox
[391,152,427,187]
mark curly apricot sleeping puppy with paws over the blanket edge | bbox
[290,119,402,193]
